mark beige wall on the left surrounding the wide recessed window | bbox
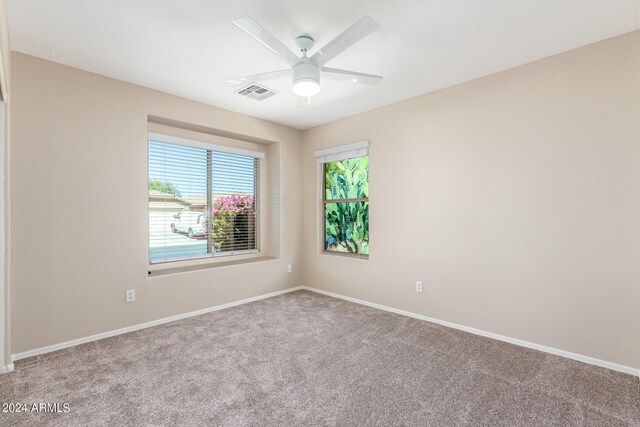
[10,53,302,354]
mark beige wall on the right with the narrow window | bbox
[302,32,640,368]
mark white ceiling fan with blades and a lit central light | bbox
[225,15,382,103]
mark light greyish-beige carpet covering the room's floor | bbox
[0,291,640,426]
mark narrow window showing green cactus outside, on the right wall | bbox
[316,143,369,257]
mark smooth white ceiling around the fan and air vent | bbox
[9,0,640,129]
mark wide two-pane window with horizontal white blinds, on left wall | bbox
[148,135,262,264]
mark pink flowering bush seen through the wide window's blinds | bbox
[212,194,255,252]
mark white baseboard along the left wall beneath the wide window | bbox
[7,286,302,362]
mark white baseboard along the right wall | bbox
[301,286,640,377]
